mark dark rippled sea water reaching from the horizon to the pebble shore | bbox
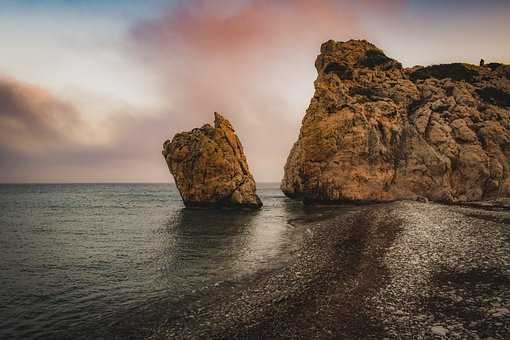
[0,184,306,339]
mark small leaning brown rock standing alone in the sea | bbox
[163,112,262,208]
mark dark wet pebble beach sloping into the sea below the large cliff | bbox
[108,202,510,339]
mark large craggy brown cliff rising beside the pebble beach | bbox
[281,40,510,203]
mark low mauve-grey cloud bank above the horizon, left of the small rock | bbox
[0,77,172,182]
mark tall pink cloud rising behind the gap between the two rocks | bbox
[133,0,378,181]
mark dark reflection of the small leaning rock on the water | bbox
[155,209,259,286]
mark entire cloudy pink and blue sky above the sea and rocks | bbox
[0,0,510,183]
